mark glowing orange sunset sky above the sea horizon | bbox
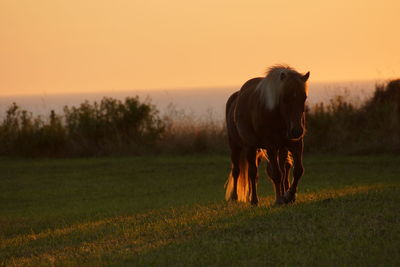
[0,0,400,95]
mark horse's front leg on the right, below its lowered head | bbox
[284,140,304,203]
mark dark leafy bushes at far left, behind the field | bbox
[0,97,165,156]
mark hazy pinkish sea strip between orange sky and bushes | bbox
[0,81,376,119]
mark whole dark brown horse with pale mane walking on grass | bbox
[225,65,310,205]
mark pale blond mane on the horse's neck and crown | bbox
[256,65,299,110]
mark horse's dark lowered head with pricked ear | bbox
[279,71,310,140]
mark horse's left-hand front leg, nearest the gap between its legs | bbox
[267,149,285,205]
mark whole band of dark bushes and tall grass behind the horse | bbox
[0,80,400,156]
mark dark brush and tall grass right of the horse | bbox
[305,80,400,153]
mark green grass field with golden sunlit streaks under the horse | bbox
[0,155,400,266]
